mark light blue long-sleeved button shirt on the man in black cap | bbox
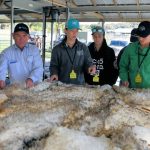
[0,43,43,83]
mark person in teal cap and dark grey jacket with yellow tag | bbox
[50,18,95,84]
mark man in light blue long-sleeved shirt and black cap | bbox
[0,23,43,89]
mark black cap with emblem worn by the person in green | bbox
[137,21,150,38]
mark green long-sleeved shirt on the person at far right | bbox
[119,42,150,88]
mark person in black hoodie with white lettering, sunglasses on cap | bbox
[85,26,118,85]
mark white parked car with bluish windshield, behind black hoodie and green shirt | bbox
[109,40,129,56]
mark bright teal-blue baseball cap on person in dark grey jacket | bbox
[65,18,80,30]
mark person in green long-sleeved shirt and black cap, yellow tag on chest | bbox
[119,21,150,88]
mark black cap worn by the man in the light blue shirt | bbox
[14,23,29,34]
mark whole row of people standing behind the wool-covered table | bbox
[0,18,150,89]
